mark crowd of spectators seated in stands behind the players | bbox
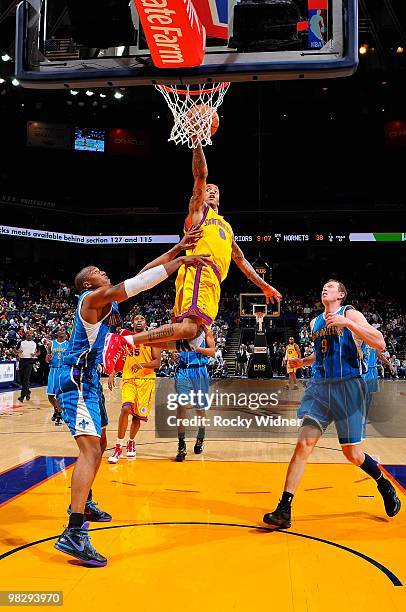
[0,277,406,383]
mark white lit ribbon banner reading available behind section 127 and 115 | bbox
[0,225,180,245]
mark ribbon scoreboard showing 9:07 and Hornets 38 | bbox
[234,232,406,245]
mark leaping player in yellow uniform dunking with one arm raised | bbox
[134,145,281,351]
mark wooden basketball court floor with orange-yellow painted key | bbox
[0,381,406,612]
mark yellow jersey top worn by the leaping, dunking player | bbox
[187,204,234,281]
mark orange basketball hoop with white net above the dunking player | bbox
[155,83,230,149]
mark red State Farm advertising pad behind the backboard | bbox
[134,0,206,68]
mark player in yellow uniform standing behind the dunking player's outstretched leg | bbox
[109,315,161,463]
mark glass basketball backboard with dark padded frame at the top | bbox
[16,0,358,89]
